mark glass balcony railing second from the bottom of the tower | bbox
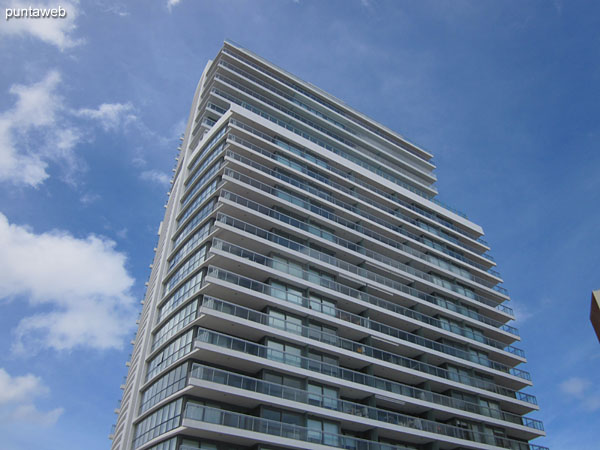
[190,364,545,442]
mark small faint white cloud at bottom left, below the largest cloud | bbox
[0,368,63,427]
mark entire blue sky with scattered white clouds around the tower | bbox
[0,0,600,450]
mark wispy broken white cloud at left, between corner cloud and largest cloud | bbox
[0,70,137,187]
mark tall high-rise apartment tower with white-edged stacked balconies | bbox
[110,42,544,450]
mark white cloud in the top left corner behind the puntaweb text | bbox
[0,1,83,51]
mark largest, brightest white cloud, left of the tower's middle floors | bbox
[0,214,135,352]
